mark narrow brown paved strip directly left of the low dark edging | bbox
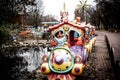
[95,31,114,80]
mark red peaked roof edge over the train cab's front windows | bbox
[49,20,85,31]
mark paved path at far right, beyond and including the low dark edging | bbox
[97,31,120,80]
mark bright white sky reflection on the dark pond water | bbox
[18,47,48,72]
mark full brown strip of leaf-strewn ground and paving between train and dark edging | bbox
[76,31,115,80]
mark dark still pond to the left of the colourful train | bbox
[0,47,49,80]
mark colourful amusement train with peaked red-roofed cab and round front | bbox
[40,2,96,80]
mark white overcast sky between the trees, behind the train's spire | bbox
[43,0,95,21]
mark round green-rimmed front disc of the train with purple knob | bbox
[48,47,74,73]
